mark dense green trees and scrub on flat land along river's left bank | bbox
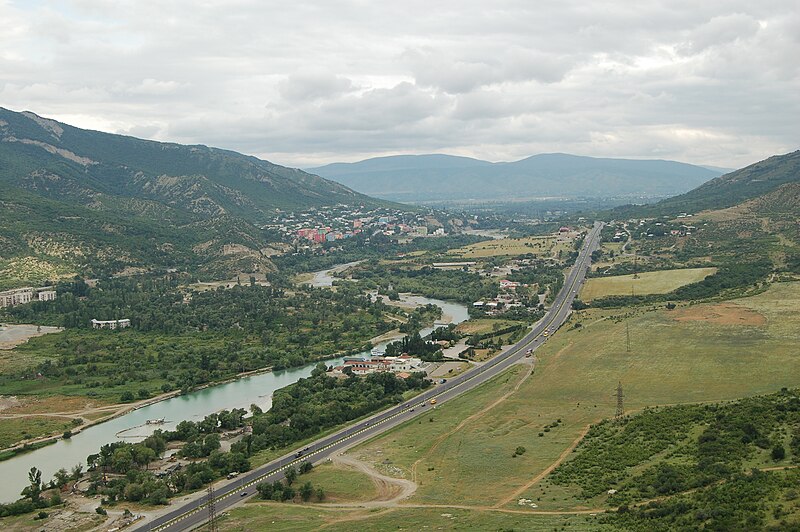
[0,277,439,400]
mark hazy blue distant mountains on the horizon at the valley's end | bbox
[307,153,723,202]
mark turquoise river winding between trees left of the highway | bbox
[0,264,469,502]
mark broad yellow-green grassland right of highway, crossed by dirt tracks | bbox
[209,282,800,530]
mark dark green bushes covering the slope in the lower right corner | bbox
[551,389,800,530]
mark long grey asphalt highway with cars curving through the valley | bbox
[134,222,602,532]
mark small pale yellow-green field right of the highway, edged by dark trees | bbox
[580,268,717,301]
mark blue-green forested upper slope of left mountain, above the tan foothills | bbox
[0,108,377,217]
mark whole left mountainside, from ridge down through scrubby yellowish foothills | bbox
[0,108,385,288]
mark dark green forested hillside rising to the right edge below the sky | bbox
[618,150,800,216]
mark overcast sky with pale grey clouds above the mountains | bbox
[0,0,800,167]
